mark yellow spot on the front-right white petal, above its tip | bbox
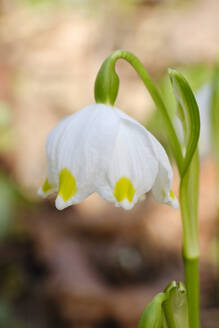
[114,177,135,203]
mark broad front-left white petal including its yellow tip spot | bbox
[41,104,119,209]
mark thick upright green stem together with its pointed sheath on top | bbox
[169,70,200,328]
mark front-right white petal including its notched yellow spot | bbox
[97,113,158,209]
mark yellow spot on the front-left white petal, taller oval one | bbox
[58,168,77,202]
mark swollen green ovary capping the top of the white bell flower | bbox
[94,56,119,105]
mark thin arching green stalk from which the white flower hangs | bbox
[96,50,183,173]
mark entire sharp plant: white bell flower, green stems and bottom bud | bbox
[39,50,200,328]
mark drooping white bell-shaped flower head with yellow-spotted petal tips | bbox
[39,104,178,210]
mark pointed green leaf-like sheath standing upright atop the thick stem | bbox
[169,69,200,177]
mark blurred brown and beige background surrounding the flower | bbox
[0,0,219,328]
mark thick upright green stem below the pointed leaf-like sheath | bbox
[180,151,199,328]
